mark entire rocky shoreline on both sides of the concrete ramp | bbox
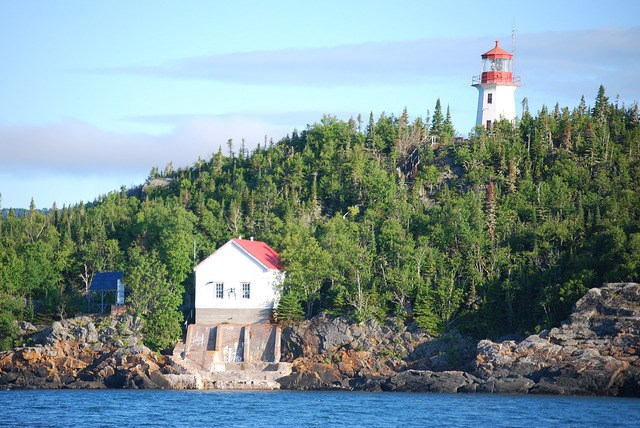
[0,283,640,397]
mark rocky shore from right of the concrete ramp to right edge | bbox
[280,283,640,397]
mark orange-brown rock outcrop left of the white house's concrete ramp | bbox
[0,315,180,389]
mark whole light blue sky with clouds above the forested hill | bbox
[0,0,640,208]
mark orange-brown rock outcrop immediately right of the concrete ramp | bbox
[279,315,475,391]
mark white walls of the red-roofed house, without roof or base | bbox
[195,241,284,318]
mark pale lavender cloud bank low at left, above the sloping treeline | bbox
[0,115,283,175]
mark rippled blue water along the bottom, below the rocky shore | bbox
[0,390,640,427]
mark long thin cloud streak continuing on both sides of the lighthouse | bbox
[101,27,640,94]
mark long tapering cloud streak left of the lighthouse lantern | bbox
[100,39,479,86]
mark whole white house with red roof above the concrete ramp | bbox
[194,238,284,325]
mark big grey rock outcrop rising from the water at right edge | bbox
[474,283,640,397]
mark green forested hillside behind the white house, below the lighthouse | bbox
[0,88,640,349]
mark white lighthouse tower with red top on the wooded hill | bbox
[472,40,520,129]
